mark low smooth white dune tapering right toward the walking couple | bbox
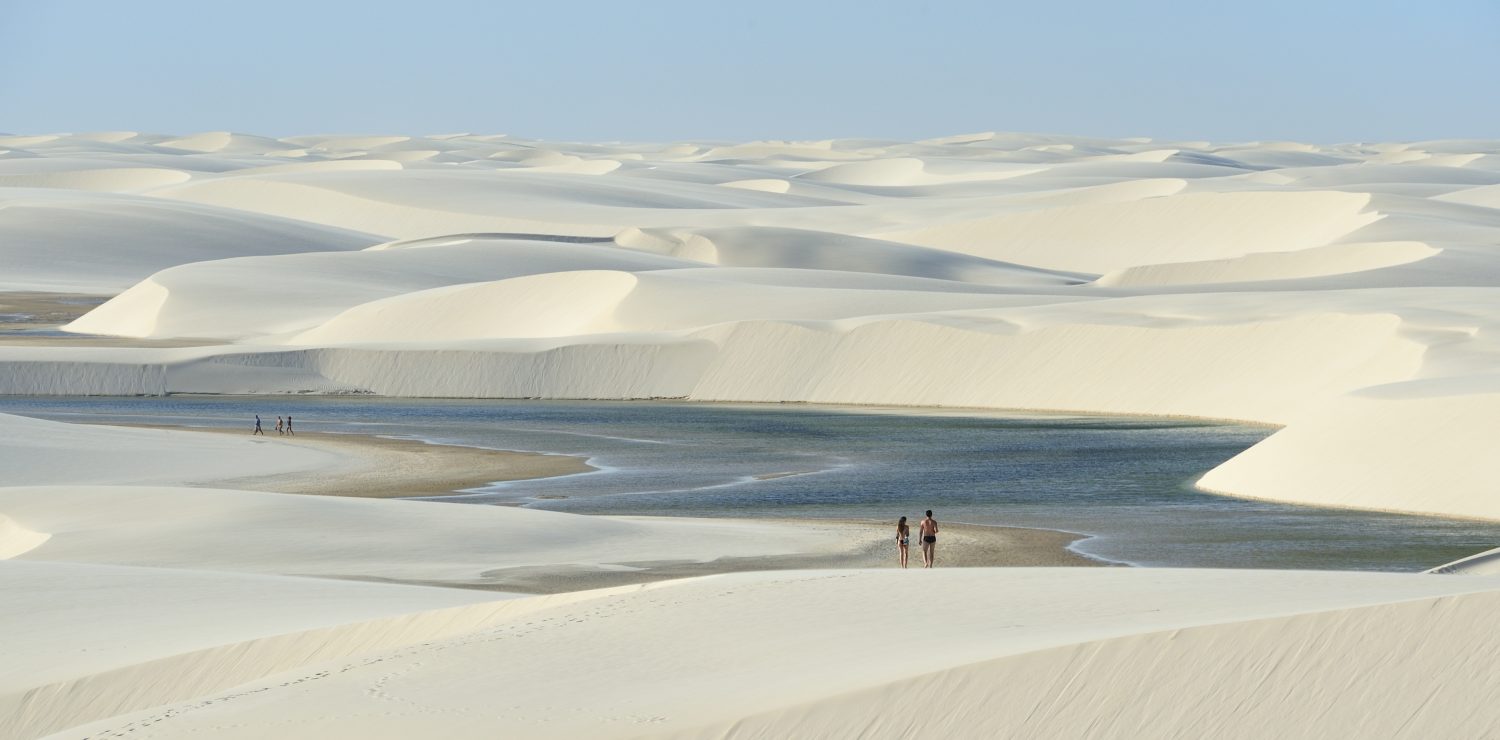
[0,485,849,587]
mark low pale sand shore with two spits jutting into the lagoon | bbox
[0,416,1098,593]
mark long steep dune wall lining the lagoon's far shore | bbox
[0,294,1416,414]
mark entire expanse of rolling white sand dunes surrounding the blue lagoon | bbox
[0,132,1500,738]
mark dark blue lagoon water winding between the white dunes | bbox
[0,396,1500,570]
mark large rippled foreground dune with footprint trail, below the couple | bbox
[35,569,1500,738]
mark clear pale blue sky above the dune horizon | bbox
[0,0,1500,143]
